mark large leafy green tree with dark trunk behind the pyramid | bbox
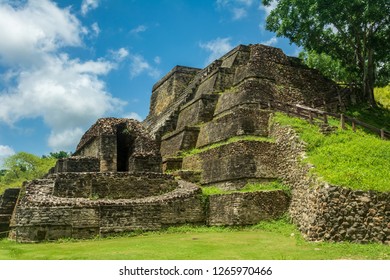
[263,0,390,106]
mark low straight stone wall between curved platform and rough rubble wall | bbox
[207,191,289,226]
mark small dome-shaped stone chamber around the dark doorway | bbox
[74,118,161,172]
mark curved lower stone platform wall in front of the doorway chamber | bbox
[10,175,205,242]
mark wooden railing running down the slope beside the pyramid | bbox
[260,99,390,140]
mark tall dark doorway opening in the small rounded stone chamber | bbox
[116,124,134,172]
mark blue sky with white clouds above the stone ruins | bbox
[0,0,298,164]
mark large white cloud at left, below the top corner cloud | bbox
[0,55,123,130]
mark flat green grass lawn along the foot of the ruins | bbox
[0,220,390,260]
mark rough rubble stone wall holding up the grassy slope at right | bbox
[271,124,390,244]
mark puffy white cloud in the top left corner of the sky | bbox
[0,0,82,65]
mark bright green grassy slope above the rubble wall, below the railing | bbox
[274,114,390,192]
